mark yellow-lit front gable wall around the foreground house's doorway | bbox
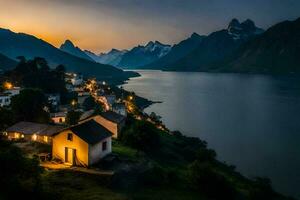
[52,130,89,166]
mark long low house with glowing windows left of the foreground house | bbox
[4,122,64,144]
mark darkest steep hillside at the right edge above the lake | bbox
[216,18,300,74]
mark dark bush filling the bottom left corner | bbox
[0,139,48,199]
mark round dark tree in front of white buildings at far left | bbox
[11,89,50,123]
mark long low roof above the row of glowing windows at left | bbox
[6,122,64,136]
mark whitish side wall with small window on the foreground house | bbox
[89,137,111,165]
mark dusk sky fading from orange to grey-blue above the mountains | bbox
[0,0,300,53]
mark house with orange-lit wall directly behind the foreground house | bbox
[80,111,126,138]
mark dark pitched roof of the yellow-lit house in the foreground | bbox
[69,119,112,144]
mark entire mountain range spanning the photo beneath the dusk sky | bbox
[0,18,300,75]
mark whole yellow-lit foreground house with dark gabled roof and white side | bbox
[52,120,112,166]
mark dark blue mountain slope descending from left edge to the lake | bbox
[0,29,136,81]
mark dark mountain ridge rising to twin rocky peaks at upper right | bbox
[163,19,263,71]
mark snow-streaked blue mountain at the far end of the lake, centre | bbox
[118,41,171,68]
